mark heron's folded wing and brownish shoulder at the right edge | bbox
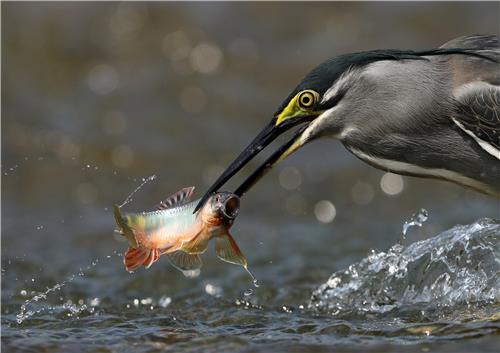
[442,36,500,159]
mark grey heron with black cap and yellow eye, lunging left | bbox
[193,35,500,212]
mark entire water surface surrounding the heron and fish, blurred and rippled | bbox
[1,3,500,352]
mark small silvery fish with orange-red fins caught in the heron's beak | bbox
[113,186,248,277]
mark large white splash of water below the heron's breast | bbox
[309,219,500,319]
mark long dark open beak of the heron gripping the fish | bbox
[194,116,315,212]
